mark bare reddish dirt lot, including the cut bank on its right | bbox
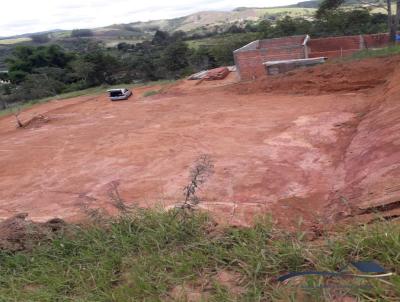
[0,59,400,226]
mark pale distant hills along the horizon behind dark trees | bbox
[0,0,388,51]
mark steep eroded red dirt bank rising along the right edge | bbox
[341,68,400,217]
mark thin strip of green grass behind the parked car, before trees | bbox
[0,80,175,117]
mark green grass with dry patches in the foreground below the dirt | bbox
[0,210,400,302]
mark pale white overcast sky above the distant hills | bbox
[0,0,301,37]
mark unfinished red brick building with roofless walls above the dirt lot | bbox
[233,34,389,81]
